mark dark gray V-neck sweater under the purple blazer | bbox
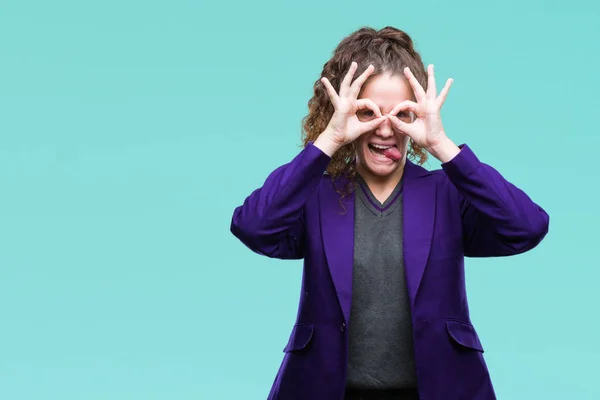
[347,177,417,389]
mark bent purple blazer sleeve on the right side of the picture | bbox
[442,145,550,257]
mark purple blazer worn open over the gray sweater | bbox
[231,143,549,400]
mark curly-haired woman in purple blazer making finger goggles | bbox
[231,27,549,400]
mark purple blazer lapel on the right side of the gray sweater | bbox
[402,160,436,304]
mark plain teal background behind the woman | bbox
[0,0,600,400]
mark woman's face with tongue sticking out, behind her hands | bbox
[356,74,414,179]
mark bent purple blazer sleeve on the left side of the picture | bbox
[230,143,331,259]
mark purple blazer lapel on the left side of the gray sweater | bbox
[319,179,354,324]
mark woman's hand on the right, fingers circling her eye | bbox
[387,64,460,162]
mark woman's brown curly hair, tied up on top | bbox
[302,26,427,196]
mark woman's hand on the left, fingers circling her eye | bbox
[314,62,386,156]
